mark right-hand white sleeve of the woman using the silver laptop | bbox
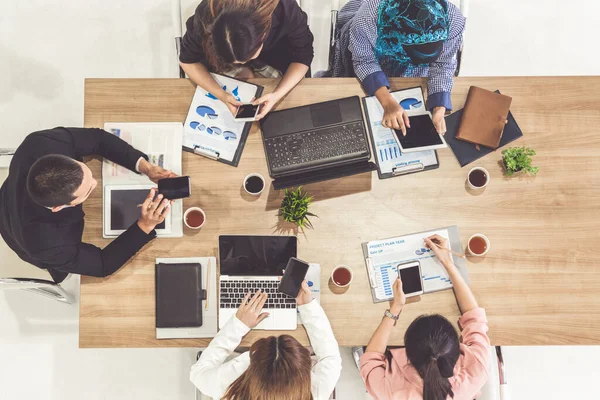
[298,300,342,400]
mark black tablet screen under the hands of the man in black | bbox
[110,189,165,231]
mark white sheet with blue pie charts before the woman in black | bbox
[183,74,263,166]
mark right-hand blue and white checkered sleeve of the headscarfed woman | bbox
[427,4,466,110]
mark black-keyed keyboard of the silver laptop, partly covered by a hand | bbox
[220,280,296,309]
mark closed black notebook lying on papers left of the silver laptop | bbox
[156,263,206,328]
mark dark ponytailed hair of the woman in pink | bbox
[404,315,460,400]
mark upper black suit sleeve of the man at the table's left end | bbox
[57,128,148,172]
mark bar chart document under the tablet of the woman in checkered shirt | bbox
[363,86,439,179]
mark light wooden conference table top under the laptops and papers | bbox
[79,77,600,347]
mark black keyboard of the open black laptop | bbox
[265,121,368,170]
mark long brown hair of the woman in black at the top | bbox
[194,0,279,72]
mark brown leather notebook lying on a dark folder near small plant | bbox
[456,86,512,149]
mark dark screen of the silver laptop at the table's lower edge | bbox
[219,236,297,276]
